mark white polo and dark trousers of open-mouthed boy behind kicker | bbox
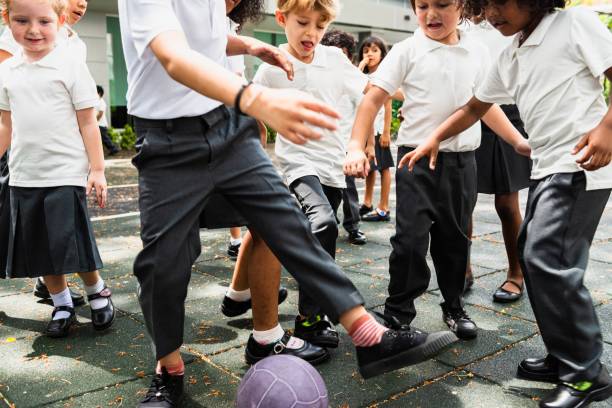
[253,45,368,316]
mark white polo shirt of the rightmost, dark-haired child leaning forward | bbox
[475,7,612,190]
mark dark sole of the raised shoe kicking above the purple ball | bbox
[359,332,458,379]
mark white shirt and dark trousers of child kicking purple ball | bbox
[119,0,364,359]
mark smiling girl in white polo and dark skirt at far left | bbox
[0,0,115,337]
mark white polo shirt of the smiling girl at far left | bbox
[0,45,99,187]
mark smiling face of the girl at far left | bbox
[5,0,64,59]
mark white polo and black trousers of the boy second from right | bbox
[372,30,489,324]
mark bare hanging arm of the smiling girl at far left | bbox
[76,108,107,208]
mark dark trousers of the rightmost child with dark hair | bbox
[518,172,610,383]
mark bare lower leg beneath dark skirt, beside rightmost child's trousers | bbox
[495,192,523,293]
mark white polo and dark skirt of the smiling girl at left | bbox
[0,44,102,278]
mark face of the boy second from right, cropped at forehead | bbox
[415,0,462,44]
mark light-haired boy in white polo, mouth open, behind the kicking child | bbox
[253,0,368,348]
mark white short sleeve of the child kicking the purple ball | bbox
[125,0,183,57]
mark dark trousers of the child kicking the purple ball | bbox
[133,106,364,359]
